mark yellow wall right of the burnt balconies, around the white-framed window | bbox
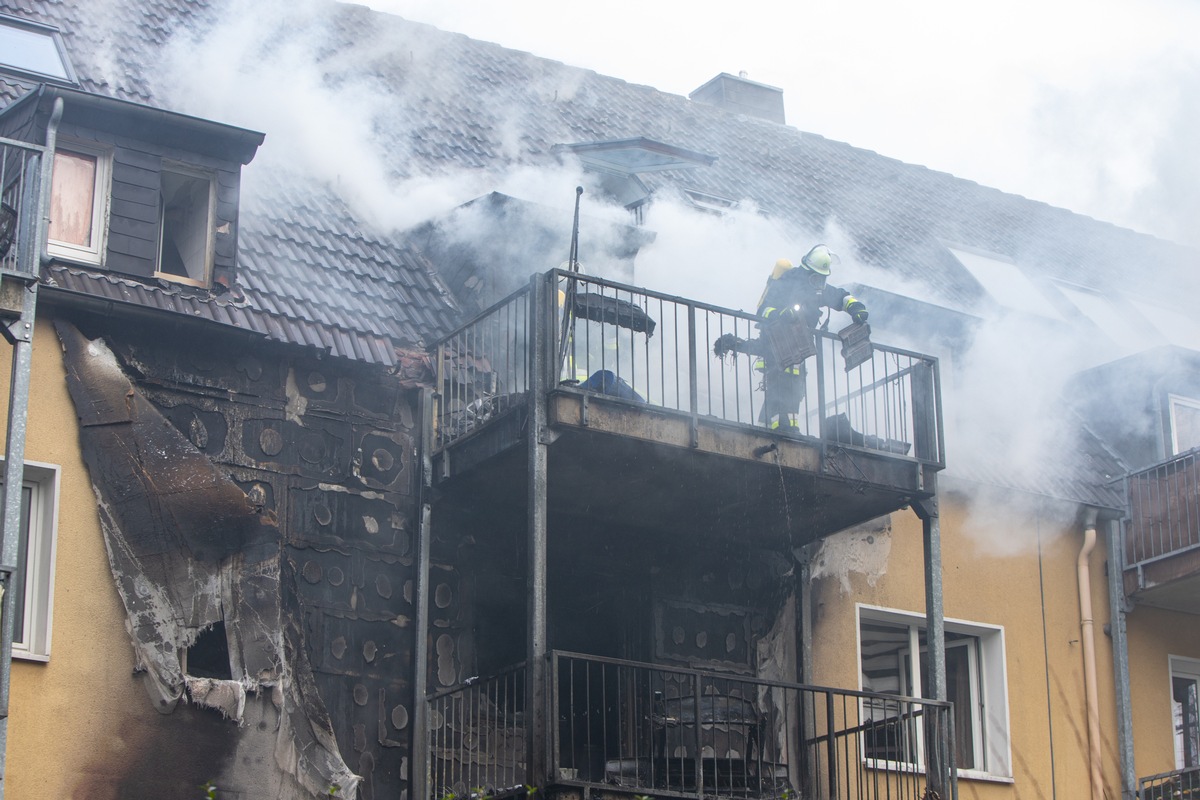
[814,487,1200,800]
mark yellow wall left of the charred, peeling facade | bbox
[0,320,156,800]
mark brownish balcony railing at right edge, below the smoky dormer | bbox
[1124,450,1200,569]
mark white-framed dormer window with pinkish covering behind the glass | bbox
[48,143,112,265]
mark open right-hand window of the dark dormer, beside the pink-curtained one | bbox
[157,164,215,285]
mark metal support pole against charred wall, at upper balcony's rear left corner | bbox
[409,385,440,800]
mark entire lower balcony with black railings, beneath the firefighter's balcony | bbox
[428,651,958,800]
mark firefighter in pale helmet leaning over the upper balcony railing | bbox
[755,245,866,433]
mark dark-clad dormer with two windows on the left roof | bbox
[0,86,263,293]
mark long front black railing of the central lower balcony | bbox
[548,652,956,800]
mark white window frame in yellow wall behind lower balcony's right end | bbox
[856,603,1013,783]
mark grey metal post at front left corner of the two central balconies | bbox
[526,273,553,787]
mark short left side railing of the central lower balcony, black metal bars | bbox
[428,664,527,800]
